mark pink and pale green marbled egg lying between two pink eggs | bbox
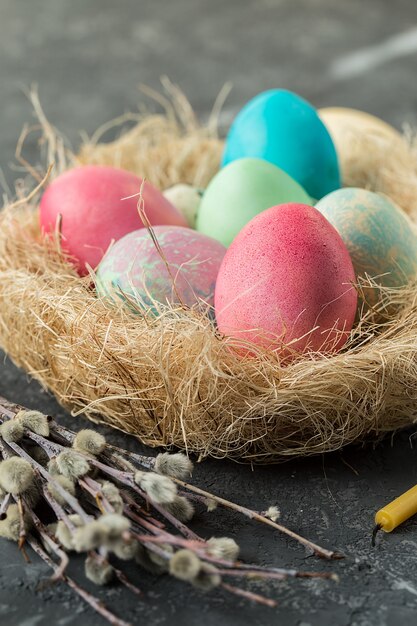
[96,226,226,313]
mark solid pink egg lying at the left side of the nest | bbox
[40,165,187,275]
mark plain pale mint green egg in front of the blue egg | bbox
[196,158,311,246]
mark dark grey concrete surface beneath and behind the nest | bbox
[0,0,417,626]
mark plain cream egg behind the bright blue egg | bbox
[319,107,417,213]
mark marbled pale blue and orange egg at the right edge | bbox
[316,188,417,305]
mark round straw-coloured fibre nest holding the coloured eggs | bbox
[0,85,417,462]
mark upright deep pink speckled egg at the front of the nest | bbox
[215,203,357,357]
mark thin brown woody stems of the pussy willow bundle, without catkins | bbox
[0,397,337,626]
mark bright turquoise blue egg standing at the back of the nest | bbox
[223,89,340,198]
